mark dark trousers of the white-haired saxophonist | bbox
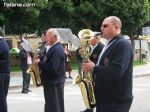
[44,83,65,112]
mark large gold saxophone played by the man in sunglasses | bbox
[74,29,96,108]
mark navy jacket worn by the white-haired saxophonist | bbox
[39,43,65,85]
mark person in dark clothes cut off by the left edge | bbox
[0,27,10,112]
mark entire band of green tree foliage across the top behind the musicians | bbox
[0,0,149,40]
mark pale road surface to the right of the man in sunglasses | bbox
[130,76,150,112]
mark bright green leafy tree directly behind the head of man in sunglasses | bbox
[100,0,145,40]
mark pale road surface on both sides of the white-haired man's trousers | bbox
[8,84,84,112]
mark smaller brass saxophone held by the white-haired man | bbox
[27,42,44,87]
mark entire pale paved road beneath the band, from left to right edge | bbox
[8,76,150,112]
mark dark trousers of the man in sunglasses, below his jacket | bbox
[96,100,132,112]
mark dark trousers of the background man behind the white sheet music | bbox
[22,66,30,90]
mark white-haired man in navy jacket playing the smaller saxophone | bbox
[35,28,65,112]
